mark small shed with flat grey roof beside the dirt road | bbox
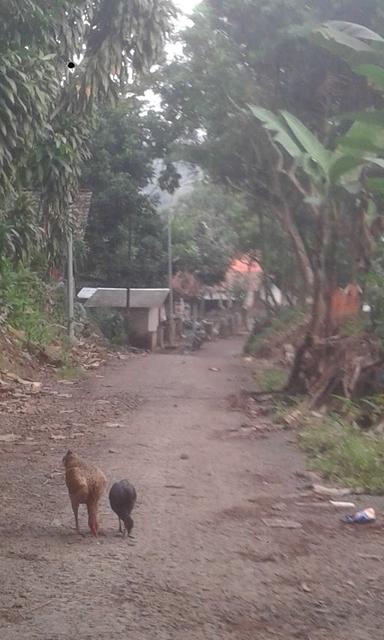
[77,287,169,350]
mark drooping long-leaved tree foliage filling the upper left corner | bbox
[0,0,174,259]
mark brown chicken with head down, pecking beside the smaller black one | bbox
[63,450,107,537]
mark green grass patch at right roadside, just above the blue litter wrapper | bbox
[300,417,384,495]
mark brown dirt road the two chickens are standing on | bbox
[0,340,384,640]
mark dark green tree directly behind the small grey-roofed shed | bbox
[81,100,167,287]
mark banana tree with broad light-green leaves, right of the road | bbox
[243,22,384,402]
